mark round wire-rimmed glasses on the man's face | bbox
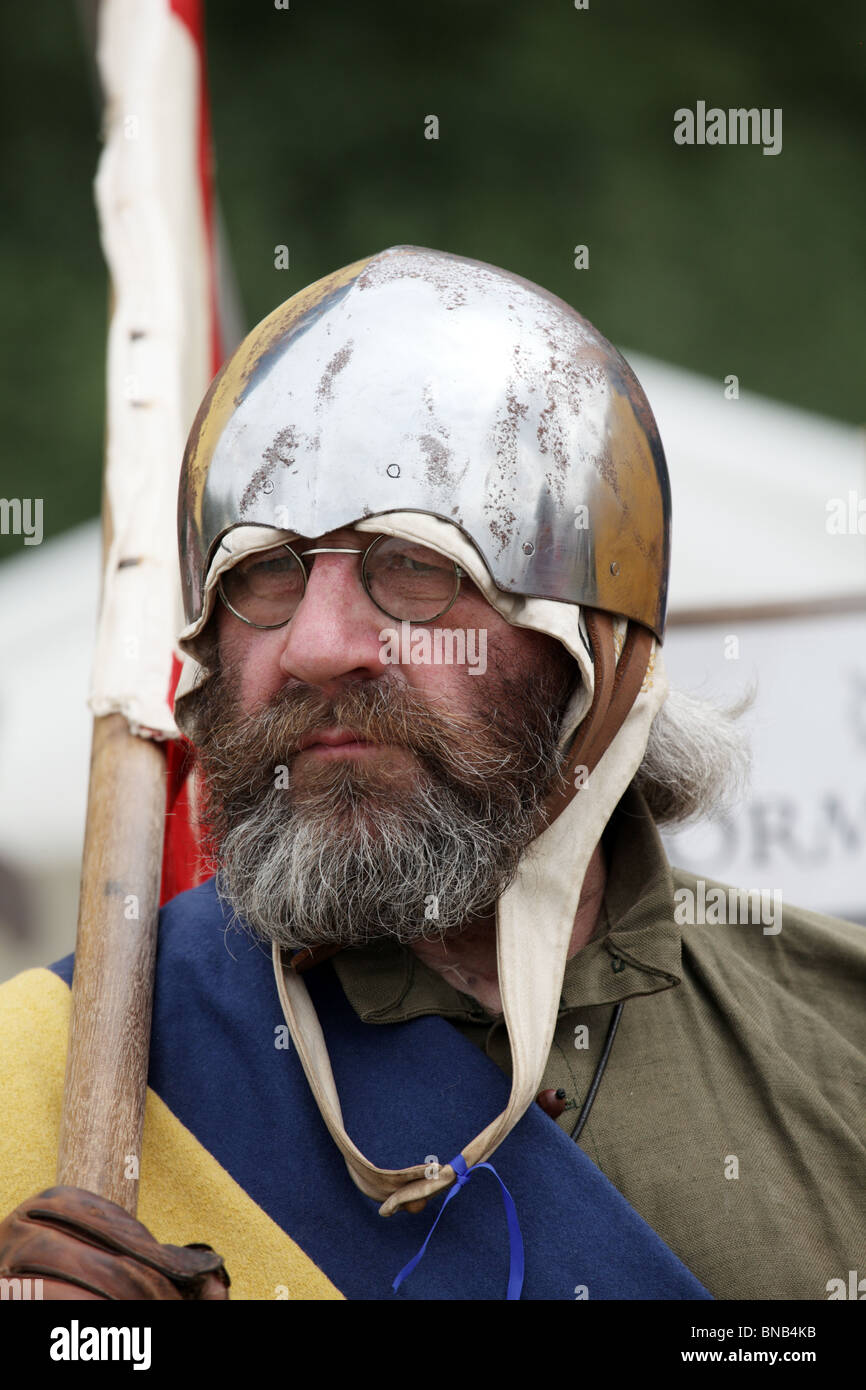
[217,535,464,628]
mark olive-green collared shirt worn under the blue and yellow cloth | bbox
[334,788,866,1298]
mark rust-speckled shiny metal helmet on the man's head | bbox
[178,246,670,639]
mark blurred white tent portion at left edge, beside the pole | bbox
[0,521,100,980]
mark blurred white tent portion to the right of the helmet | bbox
[628,354,866,922]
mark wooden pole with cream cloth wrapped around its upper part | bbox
[57,0,218,1215]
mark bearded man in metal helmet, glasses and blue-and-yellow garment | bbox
[0,247,865,1300]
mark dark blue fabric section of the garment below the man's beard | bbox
[53,878,710,1300]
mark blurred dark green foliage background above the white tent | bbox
[0,0,866,556]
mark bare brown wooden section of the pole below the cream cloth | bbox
[57,714,165,1215]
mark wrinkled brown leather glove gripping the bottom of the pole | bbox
[0,1187,231,1301]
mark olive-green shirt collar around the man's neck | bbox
[332,785,681,1023]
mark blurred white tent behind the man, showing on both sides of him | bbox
[0,353,866,979]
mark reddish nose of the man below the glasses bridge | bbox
[279,555,396,694]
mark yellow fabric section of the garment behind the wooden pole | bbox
[0,969,343,1300]
